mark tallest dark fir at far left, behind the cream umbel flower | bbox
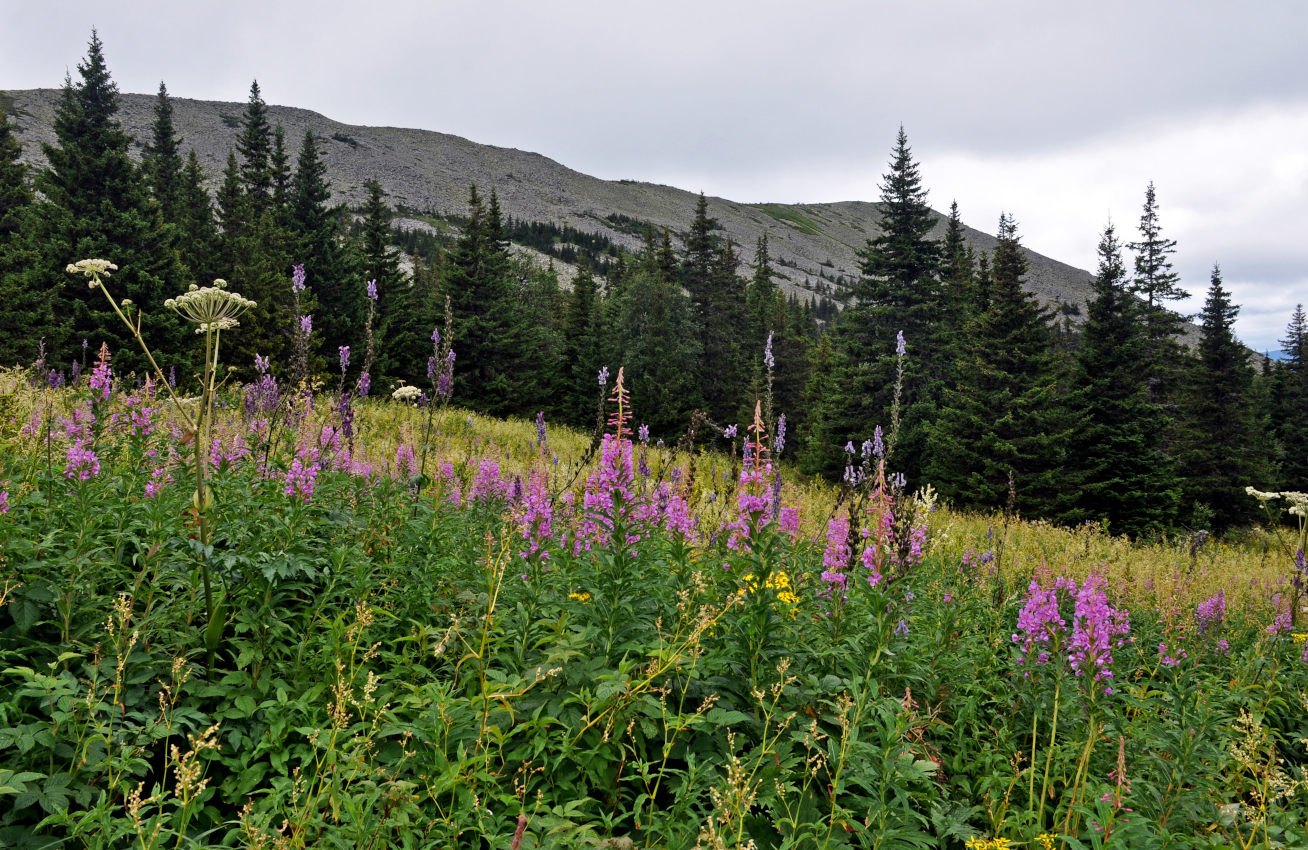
[22,31,194,373]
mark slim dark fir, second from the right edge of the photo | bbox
[1180,265,1271,530]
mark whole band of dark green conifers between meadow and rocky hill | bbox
[0,34,1308,536]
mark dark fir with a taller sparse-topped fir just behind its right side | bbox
[1061,224,1180,537]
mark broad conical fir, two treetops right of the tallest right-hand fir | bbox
[926,214,1070,517]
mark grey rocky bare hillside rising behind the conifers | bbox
[0,89,1109,320]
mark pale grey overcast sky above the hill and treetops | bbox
[0,0,1308,350]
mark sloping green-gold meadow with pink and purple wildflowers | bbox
[0,273,1308,850]
